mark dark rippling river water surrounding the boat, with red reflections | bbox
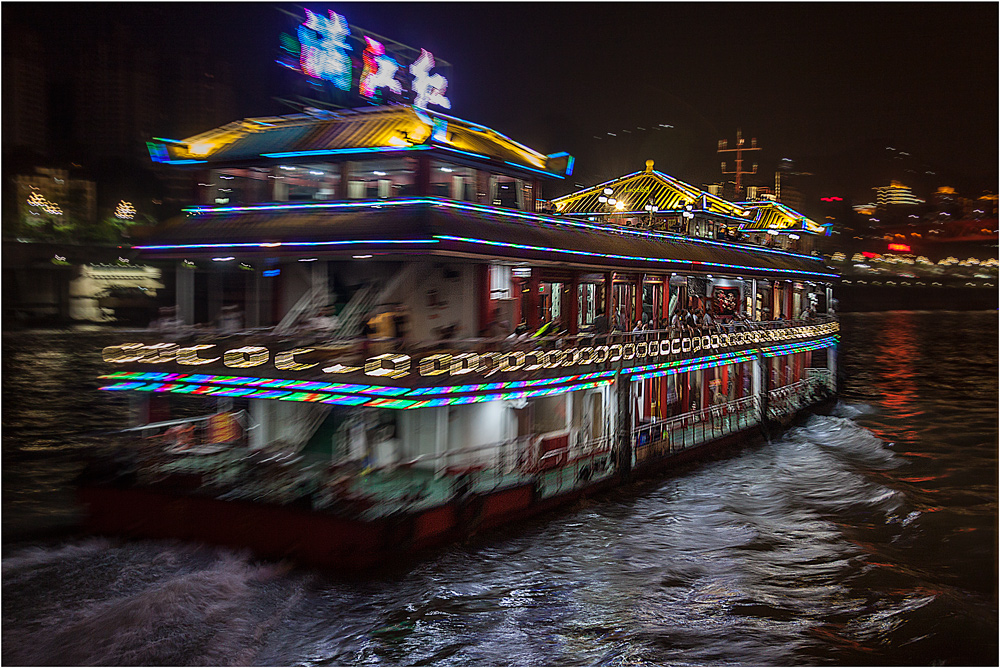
[0,311,998,666]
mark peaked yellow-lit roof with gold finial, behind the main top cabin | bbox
[552,160,744,217]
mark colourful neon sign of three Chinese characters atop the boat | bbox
[277,9,451,109]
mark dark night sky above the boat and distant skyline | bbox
[3,3,998,202]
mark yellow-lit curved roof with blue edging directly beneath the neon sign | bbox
[149,105,573,177]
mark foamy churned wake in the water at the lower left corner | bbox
[2,540,302,666]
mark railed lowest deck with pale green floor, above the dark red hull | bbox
[87,369,834,522]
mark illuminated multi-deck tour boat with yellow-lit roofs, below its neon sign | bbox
[80,6,838,567]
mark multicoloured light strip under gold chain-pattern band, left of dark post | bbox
[100,379,614,410]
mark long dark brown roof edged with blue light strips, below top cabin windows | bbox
[134,197,835,280]
